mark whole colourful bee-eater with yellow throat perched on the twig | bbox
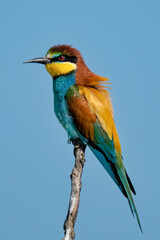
[24,44,143,233]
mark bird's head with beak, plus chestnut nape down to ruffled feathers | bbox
[24,45,107,86]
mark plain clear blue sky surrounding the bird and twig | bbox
[0,0,160,240]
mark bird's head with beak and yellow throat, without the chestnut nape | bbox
[25,45,82,78]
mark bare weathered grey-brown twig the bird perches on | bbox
[62,139,86,240]
